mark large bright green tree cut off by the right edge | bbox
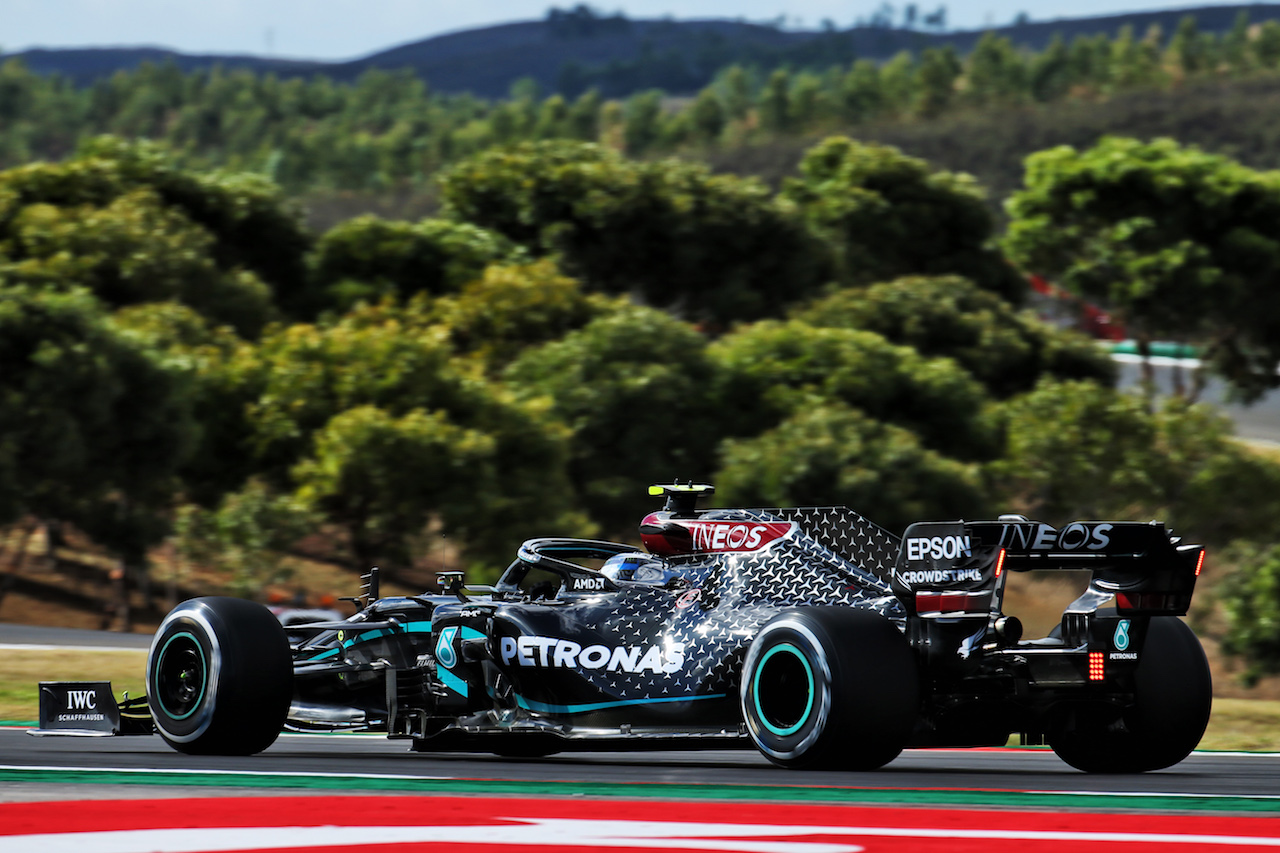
[1004,137,1280,400]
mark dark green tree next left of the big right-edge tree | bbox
[785,137,1025,301]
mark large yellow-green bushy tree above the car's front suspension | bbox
[247,304,582,569]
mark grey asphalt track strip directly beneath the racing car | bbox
[0,729,1280,808]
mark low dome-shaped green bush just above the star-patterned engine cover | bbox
[716,403,988,532]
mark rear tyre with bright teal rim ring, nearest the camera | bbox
[741,607,920,770]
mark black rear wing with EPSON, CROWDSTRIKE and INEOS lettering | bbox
[891,516,1204,616]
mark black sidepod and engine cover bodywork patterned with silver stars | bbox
[504,507,905,716]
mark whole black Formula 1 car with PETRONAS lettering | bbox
[30,485,1211,772]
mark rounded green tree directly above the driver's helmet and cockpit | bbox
[504,307,724,532]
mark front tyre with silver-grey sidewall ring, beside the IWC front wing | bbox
[147,598,293,756]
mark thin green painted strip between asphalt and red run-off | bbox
[0,768,1280,815]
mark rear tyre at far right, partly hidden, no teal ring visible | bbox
[1048,616,1213,774]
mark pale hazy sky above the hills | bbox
[0,0,1269,60]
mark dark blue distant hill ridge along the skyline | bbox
[0,3,1280,97]
